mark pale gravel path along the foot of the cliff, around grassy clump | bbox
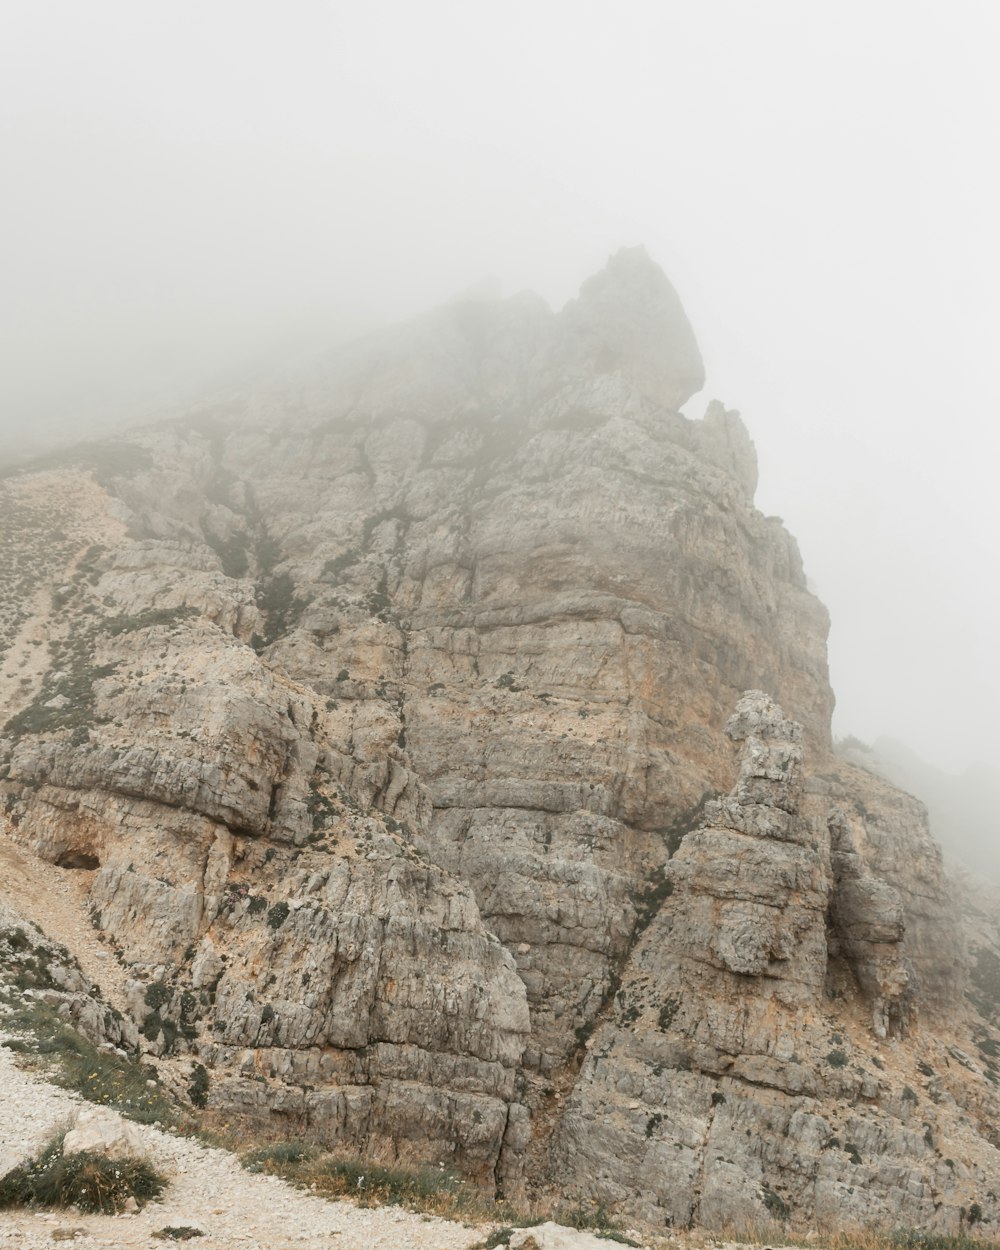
[0,1046,485,1250]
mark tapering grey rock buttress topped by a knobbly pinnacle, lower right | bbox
[551,691,1000,1231]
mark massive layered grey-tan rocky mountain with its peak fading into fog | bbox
[0,249,1000,1231]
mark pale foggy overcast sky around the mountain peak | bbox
[0,0,1000,769]
